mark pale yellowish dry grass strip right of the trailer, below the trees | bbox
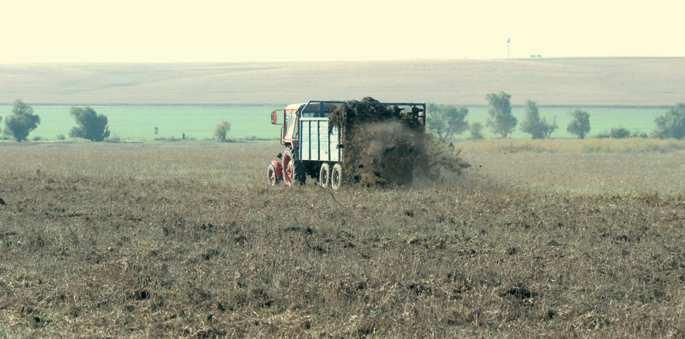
[460,139,685,194]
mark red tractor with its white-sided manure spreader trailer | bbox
[267,100,426,190]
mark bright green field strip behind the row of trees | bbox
[0,105,666,140]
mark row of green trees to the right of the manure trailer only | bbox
[428,92,685,140]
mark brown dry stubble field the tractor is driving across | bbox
[0,144,685,337]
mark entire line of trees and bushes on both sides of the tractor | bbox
[0,96,685,142]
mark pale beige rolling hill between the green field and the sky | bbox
[0,58,685,106]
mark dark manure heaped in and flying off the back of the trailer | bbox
[329,97,469,186]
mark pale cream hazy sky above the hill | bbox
[0,0,685,63]
